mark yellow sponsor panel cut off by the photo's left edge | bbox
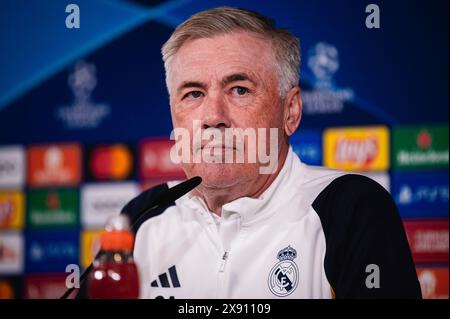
[0,191,24,229]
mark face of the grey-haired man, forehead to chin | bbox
[168,32,284,188]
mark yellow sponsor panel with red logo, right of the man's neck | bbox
[324,126,389,171]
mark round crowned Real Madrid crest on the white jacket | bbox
[269,245,298,297]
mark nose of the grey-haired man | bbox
[202,94,231,129]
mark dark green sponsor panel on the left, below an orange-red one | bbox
[27,189,79,228]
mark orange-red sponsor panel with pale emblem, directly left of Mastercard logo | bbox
[28,144,81,187]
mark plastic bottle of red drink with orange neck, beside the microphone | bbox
[88,215,139,299]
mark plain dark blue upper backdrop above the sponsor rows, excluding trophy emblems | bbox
[0,0,449,144]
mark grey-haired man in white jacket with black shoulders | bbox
[128,7,420,298]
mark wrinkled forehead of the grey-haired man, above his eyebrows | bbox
[166,32,275,87]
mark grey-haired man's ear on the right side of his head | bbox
[284,86,302,136]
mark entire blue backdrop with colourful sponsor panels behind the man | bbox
[0,0,449,298]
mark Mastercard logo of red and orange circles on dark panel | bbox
[90,144,133,180]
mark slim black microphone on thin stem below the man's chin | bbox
[60,176,202,299]
